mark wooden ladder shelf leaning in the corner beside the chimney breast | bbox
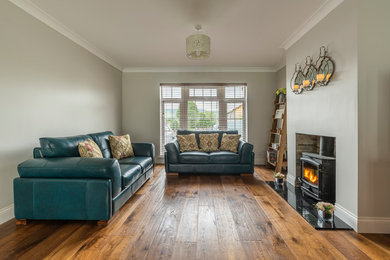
[267,95,287,172]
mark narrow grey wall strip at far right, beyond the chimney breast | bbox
[358,0,390,233]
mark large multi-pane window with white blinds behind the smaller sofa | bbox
[160,84,247,155]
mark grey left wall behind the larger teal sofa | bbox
[0,1,122,221]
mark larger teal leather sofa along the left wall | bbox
[14,131,155,221]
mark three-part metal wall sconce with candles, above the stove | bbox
[290,46,335,94]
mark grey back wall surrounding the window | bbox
[122,72,276,164]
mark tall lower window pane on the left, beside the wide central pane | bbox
[164,103,180,144]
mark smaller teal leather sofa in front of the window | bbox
[165,130,255,174]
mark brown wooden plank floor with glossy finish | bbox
[0,166,390,260]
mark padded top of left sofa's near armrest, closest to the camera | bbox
[18,157,122,197]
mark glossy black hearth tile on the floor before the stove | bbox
[266,181,352,230]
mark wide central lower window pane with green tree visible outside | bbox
[187,101,219,130]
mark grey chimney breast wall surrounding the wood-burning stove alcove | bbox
[286,0,358,228]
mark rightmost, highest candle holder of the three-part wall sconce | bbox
[316,46,335,86]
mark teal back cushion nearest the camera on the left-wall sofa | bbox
[39,135,89,158]
